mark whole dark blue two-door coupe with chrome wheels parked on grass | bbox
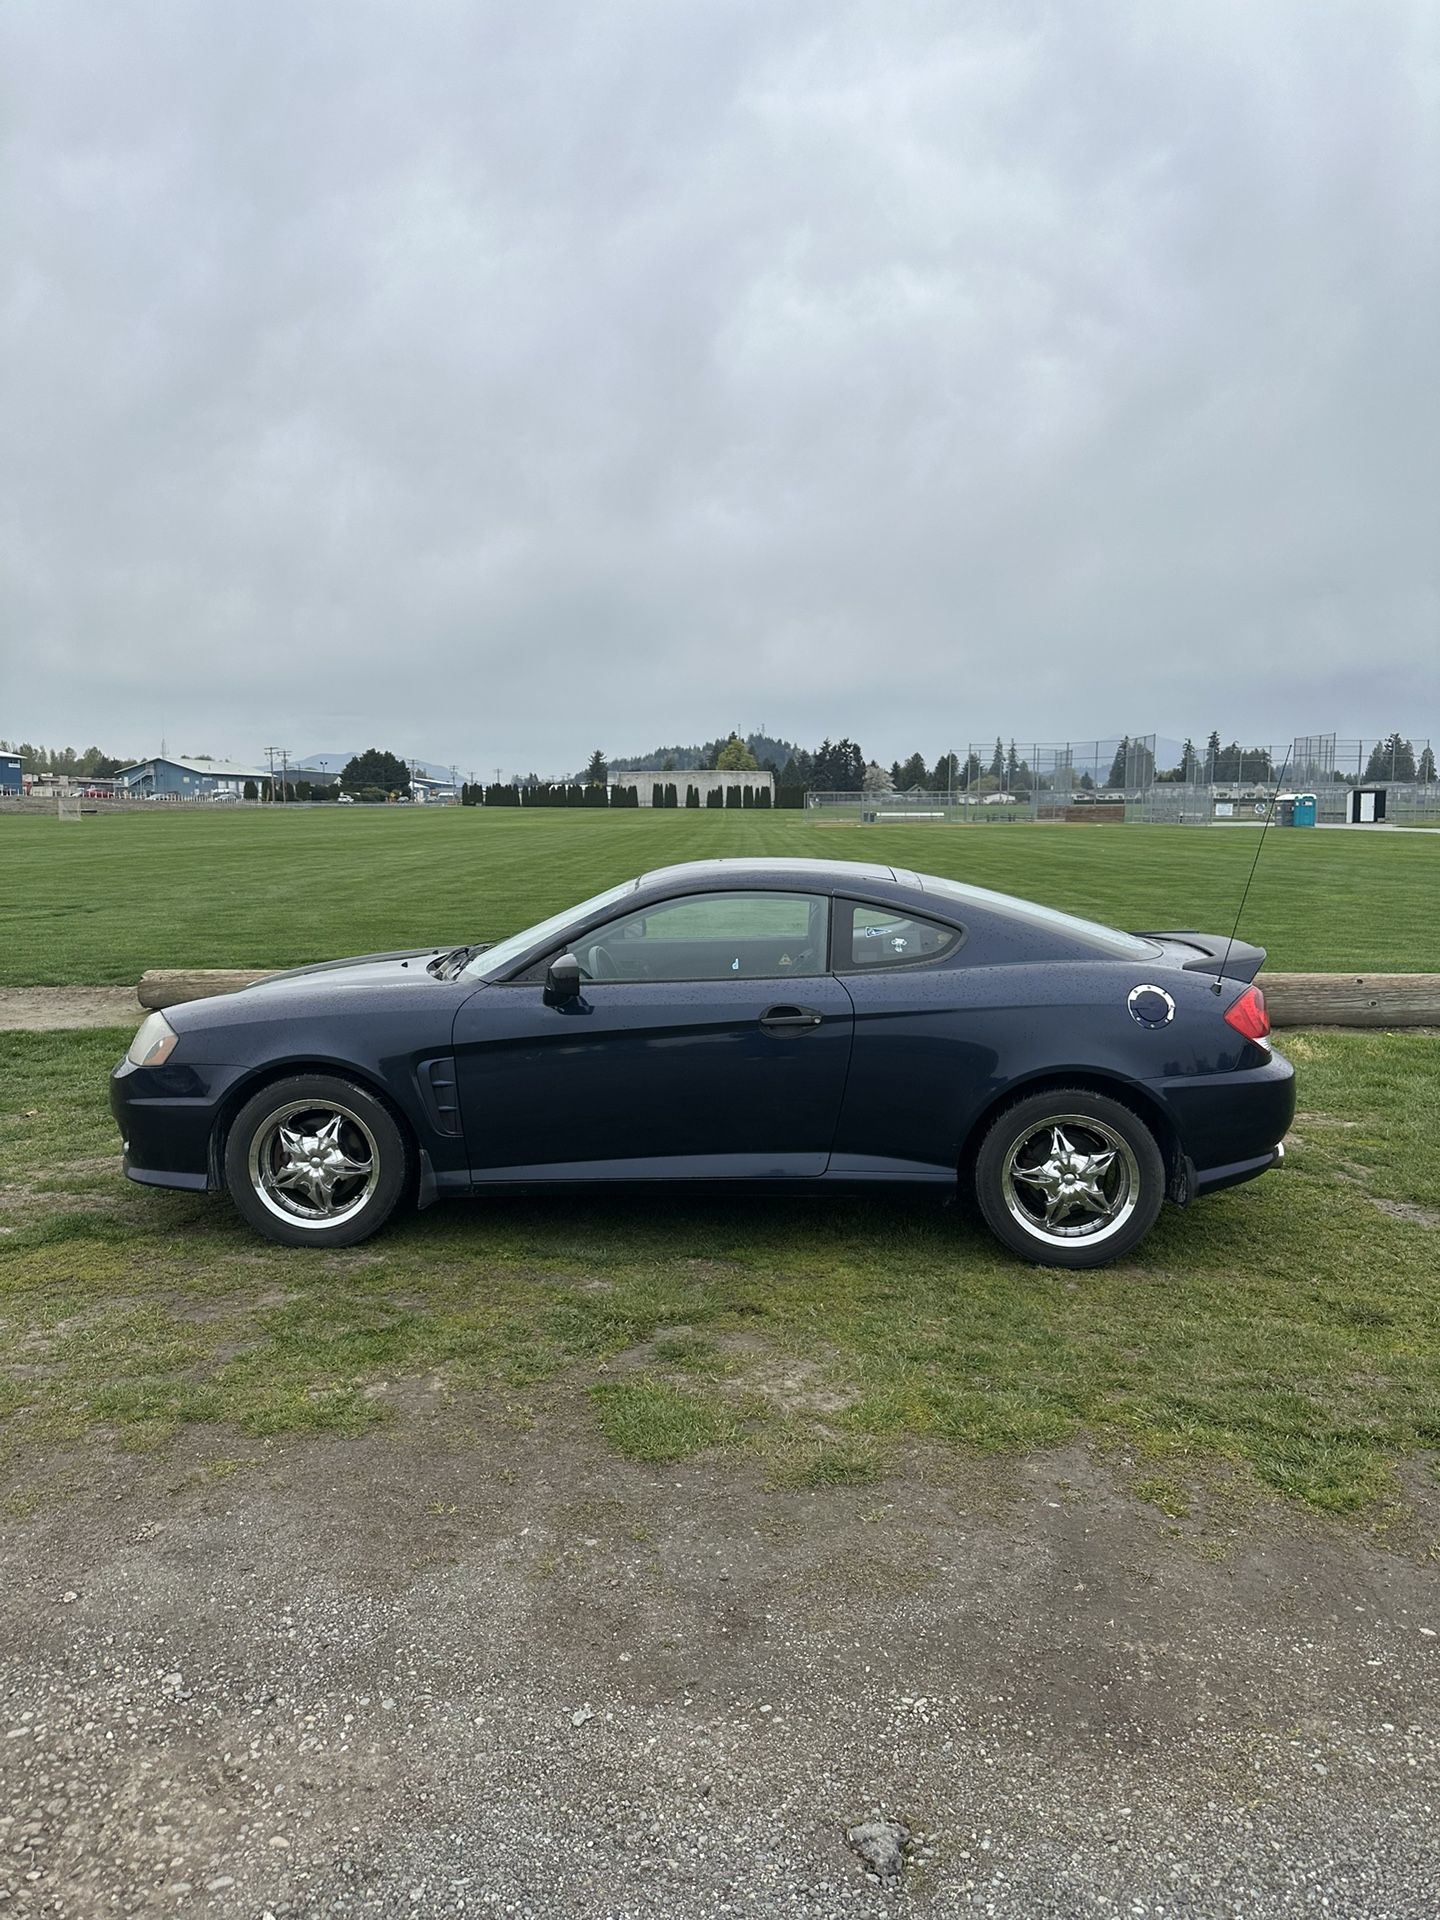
[111,860,1294,1267]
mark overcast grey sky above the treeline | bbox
[0,0,1440,772]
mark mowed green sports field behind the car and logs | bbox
[0,806,1440,987]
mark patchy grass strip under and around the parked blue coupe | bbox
[0,1033,1440,1515]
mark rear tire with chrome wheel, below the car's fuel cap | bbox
[975,1087,1165,1267]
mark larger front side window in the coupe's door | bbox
[574,893,829,983]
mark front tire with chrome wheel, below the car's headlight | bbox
[225,1073,409,1246]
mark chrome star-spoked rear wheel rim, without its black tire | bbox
[1000,1114,1140,1246]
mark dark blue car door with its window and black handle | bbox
[455,891,854,1185]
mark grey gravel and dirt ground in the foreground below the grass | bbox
[0,1394,1440,1920]
